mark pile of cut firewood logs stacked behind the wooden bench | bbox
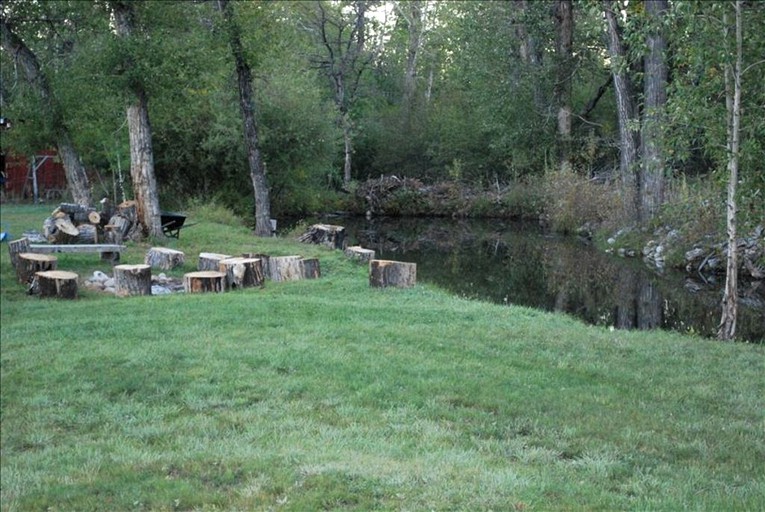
[43,200,141,244]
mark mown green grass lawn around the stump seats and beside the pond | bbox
[0,205,765,511]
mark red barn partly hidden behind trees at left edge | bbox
[4,149,66,199]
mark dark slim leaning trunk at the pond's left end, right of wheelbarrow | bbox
[218,0,271,236]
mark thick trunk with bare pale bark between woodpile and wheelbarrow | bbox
[109,0,162,237]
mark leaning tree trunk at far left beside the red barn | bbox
[0,17,92,205]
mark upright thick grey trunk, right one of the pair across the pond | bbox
[640,0,669,222]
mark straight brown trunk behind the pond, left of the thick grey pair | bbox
[555,0,574,172]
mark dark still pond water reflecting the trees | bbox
[288,217,765,342]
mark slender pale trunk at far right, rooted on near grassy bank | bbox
[717,0,743,340]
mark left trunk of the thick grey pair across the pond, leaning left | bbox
[603,0,640,220]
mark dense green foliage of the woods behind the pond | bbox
[0,0,765,230]
